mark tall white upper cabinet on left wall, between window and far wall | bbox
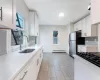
[29,11,39,36]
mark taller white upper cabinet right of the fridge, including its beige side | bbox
[82,15,98,37]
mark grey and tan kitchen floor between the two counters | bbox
[37,53,74,80]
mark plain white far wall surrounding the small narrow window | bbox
[40,25,67,52]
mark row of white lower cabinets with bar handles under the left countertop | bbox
[14,49,43,80]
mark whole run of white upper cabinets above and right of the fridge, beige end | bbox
[74,15,98,37]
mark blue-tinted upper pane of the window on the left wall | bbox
[16,13,24,28]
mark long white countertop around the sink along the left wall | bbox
[0,46,42,80]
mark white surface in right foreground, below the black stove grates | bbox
[74,55,100,80]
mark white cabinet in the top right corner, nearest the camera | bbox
[91,0,100,24]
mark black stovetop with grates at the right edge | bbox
[77,52,100,67]
